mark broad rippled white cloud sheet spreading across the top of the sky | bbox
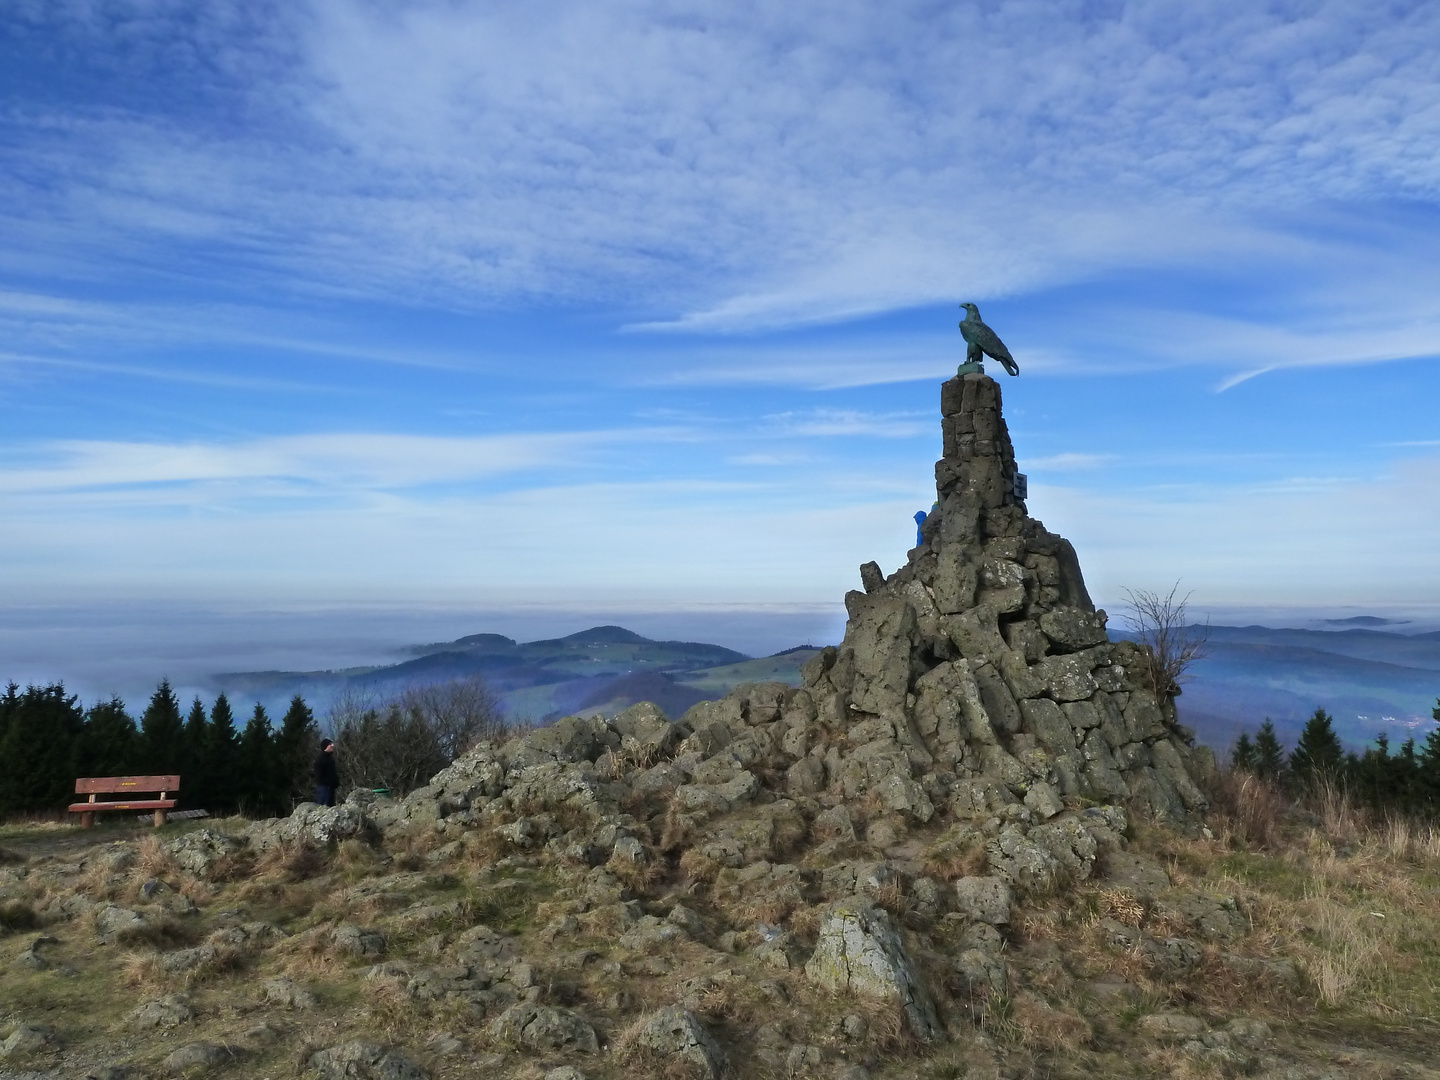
[7,0,1440,342]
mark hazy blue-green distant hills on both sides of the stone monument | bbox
[212,615,1440,750]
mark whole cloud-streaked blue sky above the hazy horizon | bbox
[0,0,1440,694]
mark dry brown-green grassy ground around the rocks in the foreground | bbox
[0,776,1440,1080]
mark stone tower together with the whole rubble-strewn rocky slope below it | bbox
[146,374,1221,1077]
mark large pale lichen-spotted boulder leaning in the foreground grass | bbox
[805,899,940,1043]
